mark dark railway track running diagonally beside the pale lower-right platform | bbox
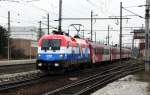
[44,64,144,95]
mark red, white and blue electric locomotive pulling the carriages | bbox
[37,34,90,70]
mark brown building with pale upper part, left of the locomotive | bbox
[10,26,38,59]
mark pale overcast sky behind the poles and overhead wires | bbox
[0,0,145,46]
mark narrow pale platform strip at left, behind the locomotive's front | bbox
[0,59,36,66]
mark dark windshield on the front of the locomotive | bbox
[42,39,60,50]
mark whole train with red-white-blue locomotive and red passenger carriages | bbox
[36,34,131,71]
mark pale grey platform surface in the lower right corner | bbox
[91,71,150,95]
